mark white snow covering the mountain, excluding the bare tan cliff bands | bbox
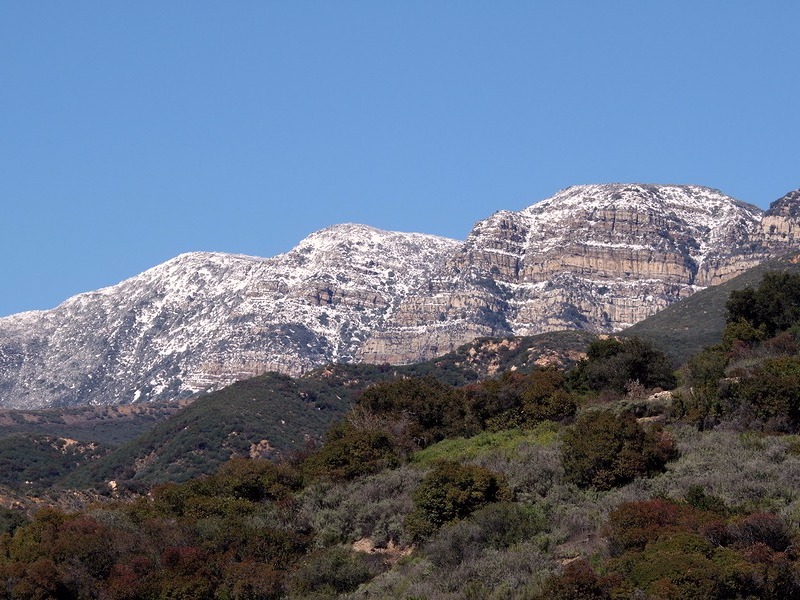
[0,184,780,406]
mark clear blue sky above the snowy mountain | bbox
[0,0,800,315]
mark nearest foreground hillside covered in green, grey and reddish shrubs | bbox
[0,273,800,599]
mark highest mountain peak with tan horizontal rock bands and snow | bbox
[360,184,764,362]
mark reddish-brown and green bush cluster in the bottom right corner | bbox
[541,494,800,600]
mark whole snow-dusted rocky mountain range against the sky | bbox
[0,184,800,408]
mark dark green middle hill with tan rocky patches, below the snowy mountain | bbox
[53,331,593,492]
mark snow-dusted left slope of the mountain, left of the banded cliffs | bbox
[0,225,458,408]
